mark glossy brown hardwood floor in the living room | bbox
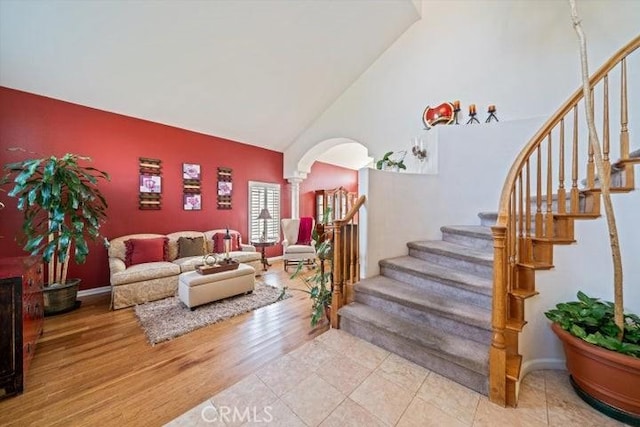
[0,262,328,427]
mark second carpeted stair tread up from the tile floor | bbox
[355,276,491,329]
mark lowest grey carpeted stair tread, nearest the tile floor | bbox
[339,302,490,375]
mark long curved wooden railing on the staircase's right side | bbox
[489,36,640,406]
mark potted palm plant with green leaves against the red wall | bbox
[0,154,109,314]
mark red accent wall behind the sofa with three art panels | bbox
[0,87,291,289]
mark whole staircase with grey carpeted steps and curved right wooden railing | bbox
[332,36,640,406]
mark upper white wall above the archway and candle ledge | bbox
[284,0,640,178]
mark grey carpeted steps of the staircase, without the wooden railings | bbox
[339,226,493,395]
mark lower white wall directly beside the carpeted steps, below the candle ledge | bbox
[358,119,541,277]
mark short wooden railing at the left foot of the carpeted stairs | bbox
[331,195,366,329]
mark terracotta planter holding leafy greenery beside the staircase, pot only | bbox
[551,323,640,424]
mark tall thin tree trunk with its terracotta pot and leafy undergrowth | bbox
[545,0,640,425]
